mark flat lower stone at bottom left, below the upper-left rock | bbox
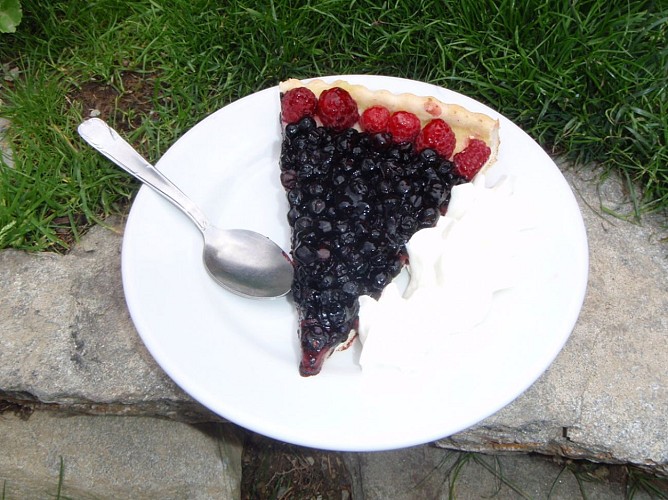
[0,412,242,500]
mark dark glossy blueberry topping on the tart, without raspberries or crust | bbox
[280,117,465,375]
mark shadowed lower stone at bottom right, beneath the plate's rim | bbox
[345,446,636,500]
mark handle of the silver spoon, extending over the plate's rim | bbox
[77,118,209,233]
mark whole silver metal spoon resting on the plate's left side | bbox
[78,118,293,298]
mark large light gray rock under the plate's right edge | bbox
[438,165,668,475]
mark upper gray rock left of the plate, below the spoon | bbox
[0,220,215,421]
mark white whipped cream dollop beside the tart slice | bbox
[358,174,533,371]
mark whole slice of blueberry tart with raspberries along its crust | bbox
[279,80,499,376]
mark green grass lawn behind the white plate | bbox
[0,0,668,251]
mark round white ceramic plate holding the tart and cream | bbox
[122,76,588,451]
